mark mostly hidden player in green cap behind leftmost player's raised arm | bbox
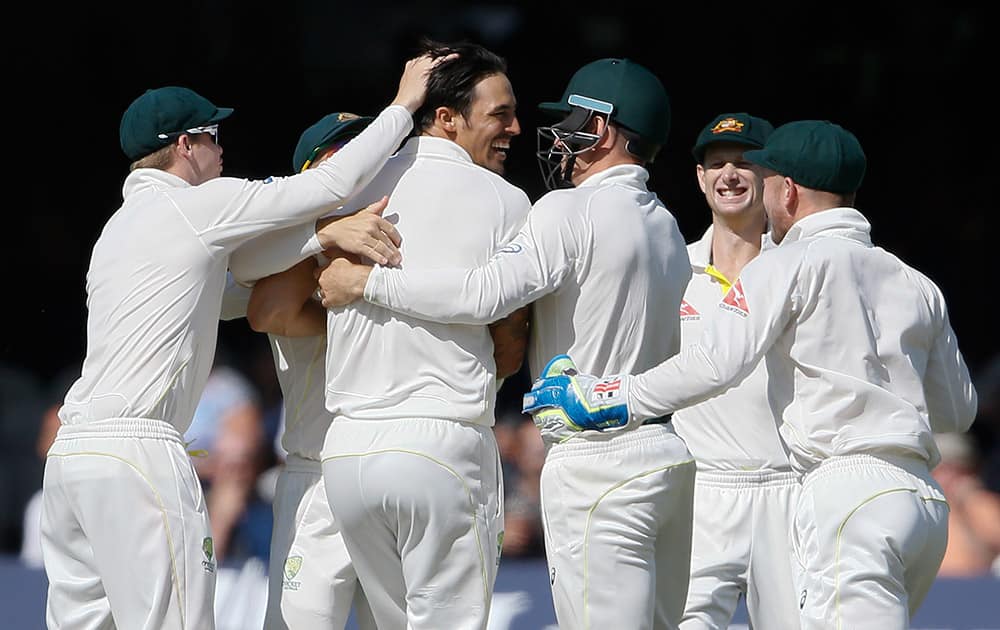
[223,112,375,630]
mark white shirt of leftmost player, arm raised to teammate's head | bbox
[59,106,413,433]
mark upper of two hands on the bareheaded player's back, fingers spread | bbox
[316,197,403,266]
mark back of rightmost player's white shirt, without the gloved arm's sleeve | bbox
[756,209,975,467]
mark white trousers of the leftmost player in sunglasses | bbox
[42,418,216,630]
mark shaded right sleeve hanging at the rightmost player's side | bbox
[924,281,978,433]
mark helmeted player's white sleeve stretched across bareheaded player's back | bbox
[365,198,592,324]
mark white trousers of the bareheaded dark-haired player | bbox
[323,418,503,630]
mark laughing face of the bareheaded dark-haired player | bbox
[453,74,521,175]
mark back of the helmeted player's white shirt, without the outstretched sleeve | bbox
[529,166,691,376]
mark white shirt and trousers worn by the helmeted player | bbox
[365,165,694,628]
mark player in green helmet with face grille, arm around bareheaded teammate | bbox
[320,58,695,629]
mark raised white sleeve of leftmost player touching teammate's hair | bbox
[182,105,413,253]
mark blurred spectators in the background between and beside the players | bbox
[0,346,1000,577]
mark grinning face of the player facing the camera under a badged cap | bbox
[698,143,764,222]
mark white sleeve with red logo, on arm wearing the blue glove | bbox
[629,252,798,420]
